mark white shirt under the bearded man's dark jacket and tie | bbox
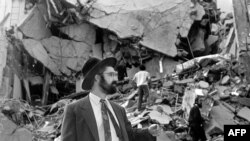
[89,93,119,141]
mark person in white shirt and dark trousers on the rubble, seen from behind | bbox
[133,65,150,110]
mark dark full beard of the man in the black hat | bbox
[99,76,116,95]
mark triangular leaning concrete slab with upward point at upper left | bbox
[19,6,51,40]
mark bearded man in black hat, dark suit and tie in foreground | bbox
[61,58,160,141]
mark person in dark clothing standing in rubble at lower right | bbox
[188,97,207,141]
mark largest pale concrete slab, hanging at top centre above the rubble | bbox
[90,0,193,57]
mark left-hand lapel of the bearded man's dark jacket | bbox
[81,96,99,141]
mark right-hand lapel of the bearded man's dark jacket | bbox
[110,101,128,141]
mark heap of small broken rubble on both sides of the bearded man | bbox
[1,54,250,140]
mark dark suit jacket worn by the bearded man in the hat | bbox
[61,96,155,141]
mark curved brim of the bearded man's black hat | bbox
[82,57,117,91]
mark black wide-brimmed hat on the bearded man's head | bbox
[82,57,117,91]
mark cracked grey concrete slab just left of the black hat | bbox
[41,36,92,75]
